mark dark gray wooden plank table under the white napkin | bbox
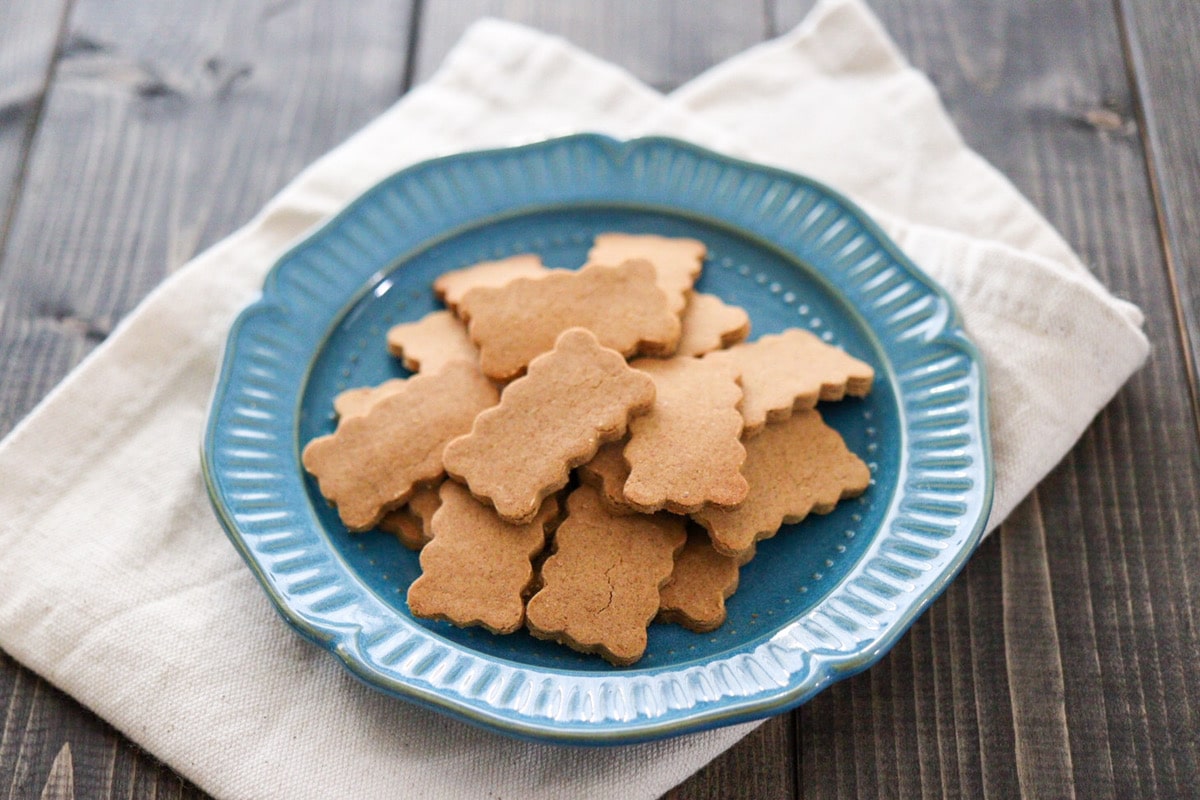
[0,0,1200,800]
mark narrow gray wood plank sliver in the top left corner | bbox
[0,0,68,252]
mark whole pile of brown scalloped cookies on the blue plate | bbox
[302,233,874,666]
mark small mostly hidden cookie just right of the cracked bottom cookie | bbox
[656,527,739,633]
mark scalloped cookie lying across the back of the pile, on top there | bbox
[458,261,679,380]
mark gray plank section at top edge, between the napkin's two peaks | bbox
[416,0,767,91]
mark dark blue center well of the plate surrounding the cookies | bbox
[299,205,900,672]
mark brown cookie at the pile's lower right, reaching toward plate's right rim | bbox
[692,409,871,557]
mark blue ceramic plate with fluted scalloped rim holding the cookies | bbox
[204,134,991,744]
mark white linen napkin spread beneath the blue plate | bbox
[0,0,1148,799]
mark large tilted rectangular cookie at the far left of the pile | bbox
[301,361,504,530]
